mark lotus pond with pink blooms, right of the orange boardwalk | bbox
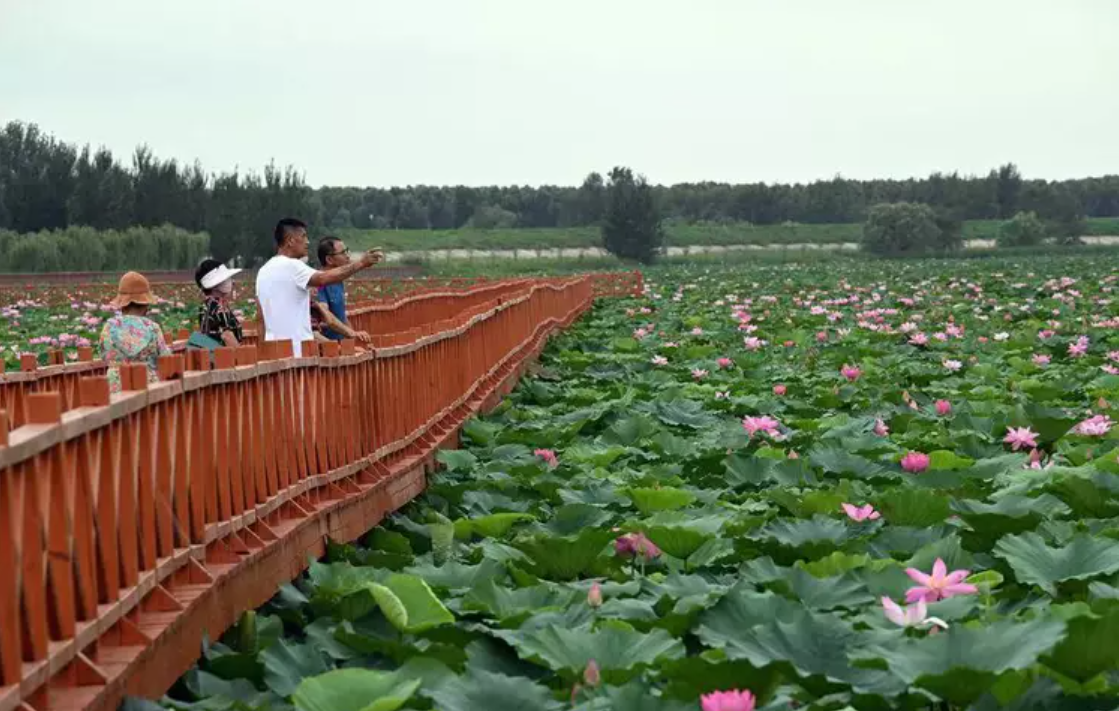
[142,259,1119,711]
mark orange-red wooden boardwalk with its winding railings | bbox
[0,270,640,711]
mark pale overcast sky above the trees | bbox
[0,0,1119,186]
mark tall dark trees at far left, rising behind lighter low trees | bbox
[0,122,311,264]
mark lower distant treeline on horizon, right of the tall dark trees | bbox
[316,165,1119,230]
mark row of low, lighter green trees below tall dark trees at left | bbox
[0,225,210,273]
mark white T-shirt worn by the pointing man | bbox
[256,254,314,357]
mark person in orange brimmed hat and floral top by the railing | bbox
[101,272,171,393]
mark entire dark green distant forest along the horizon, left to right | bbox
[0,122,1119,259]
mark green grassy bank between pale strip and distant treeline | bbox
[339,217,1119,252]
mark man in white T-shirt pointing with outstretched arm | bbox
[256,217,382,357]
